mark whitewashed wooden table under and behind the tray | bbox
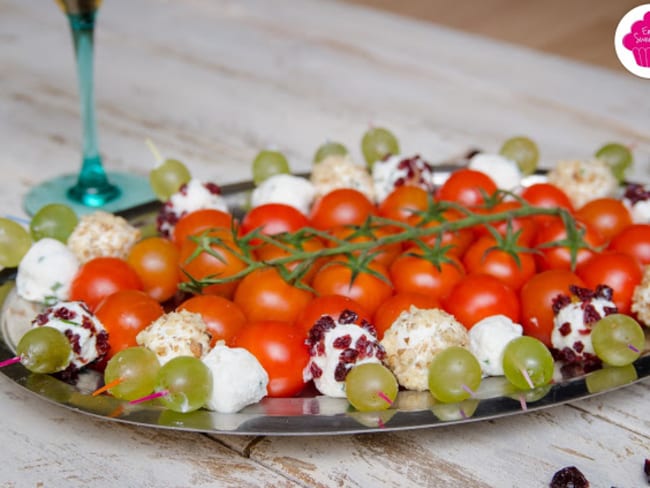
[0,0,650,487]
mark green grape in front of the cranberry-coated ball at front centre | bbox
[345,363,398,412]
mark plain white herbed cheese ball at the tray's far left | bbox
[16,237,79,304]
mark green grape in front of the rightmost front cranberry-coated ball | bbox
[591,313,645,366]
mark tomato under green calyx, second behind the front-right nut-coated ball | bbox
[389,249,465,300]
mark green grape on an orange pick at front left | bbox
[104,347,160,400]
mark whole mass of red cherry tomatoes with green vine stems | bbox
[71,169,650,396]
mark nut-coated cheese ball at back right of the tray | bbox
[548,159,618,209]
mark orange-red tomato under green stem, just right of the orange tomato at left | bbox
[179,231,246,298]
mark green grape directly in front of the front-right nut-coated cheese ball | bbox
[429,346,482,403]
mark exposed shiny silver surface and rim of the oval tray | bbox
[0,175,650,435]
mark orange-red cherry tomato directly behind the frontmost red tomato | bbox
[233,268,313,323]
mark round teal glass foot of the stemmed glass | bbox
[23,172,156,215]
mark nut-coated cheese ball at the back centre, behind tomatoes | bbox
[311,155,375,202]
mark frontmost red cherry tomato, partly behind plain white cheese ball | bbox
[233,320,309,397]
